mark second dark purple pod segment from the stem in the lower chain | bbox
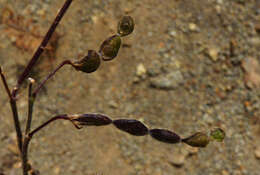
[113,119,148,136]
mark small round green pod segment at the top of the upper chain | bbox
[117,16,135,37]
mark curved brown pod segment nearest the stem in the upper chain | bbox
[72,50,101,73]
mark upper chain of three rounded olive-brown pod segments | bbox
[72,16,134,73]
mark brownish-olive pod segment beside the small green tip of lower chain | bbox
[182,132,210,147]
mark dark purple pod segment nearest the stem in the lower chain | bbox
[71,114,112,126]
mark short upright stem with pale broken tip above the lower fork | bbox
[25,78,35,135]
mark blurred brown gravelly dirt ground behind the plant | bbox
[0,0,260,175]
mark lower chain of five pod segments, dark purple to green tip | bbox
[70,114,225,147]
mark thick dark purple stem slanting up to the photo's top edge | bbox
[12,0,73,97]
